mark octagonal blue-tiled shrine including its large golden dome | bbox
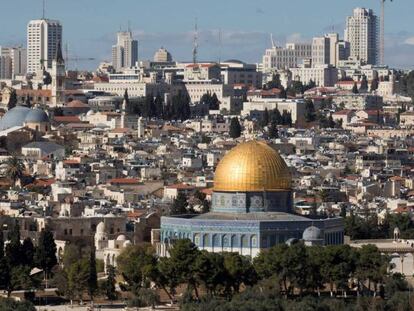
[157,140,344,257]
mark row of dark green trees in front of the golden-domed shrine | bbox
[117,240,404,310]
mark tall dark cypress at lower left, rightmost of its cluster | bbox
[34,227,57,286]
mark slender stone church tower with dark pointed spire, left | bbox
[52,42,66,106]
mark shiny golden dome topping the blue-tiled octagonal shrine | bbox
[214,140,292,192]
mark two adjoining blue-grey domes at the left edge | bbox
[0,106,49,130]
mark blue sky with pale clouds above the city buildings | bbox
[0,0,414,69]
